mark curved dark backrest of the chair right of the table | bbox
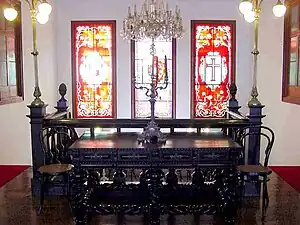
[235,125,275,167]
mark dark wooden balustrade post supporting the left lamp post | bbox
[27,104,47,195]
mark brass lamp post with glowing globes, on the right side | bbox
[239,0,286,107]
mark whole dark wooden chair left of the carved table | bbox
[38,127,78,214]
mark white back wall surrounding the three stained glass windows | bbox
[56,0,252,118]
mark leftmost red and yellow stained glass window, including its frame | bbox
[72,21,116,118]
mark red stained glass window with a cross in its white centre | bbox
[191,21,235,118]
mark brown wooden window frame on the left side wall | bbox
[0,0,24,105]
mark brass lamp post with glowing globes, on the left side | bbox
[3,0,52,107]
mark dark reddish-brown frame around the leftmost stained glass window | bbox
[71,20,117,119]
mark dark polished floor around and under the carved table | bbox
[0,170,300,225]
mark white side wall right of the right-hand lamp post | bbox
[258,1,300,165]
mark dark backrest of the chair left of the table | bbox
[40,127,78,165]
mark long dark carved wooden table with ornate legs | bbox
[68,133,242,225]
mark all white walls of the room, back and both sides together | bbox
[4,0,284,164]
